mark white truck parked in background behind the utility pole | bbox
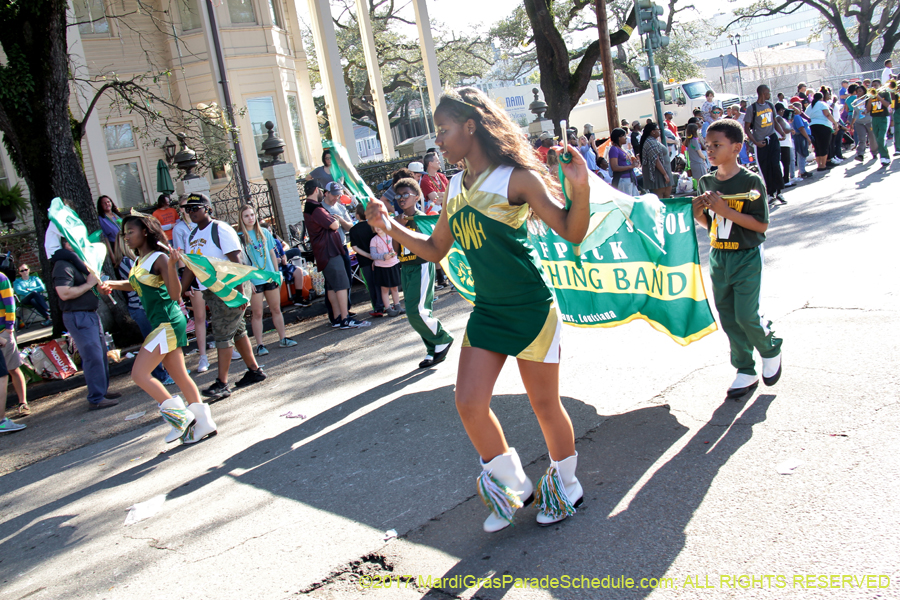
[569,79,740,138]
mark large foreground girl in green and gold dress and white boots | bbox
[367,88,589,532]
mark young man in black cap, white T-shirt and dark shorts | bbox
[181,194,266,400]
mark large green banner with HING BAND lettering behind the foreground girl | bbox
[416,195,716,346]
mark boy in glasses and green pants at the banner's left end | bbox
[394,179,453,369]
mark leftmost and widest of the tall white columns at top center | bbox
[302,0,359,164]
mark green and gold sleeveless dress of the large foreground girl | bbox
[442,166,562,363]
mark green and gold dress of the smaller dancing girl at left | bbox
[128,252,187,354]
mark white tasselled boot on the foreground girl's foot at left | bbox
[475,448,534,533]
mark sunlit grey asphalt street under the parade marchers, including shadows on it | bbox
[0,161,900,600]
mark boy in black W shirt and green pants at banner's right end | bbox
[694,119,781,400]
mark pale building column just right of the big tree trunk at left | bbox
[67,0,120,206]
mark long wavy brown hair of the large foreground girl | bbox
[434,87,561,199]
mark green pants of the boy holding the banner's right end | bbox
[709,246,782,375]
